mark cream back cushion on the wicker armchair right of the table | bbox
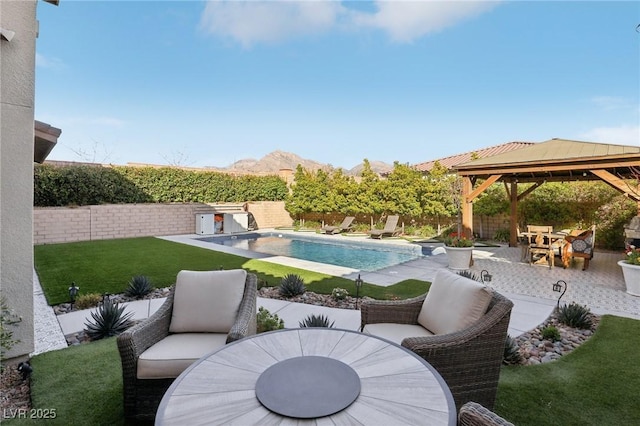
[418,269,492,334]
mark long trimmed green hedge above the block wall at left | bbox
[34,165,287,207]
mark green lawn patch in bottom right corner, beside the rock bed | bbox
[495,315,640,426]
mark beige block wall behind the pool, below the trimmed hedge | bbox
[33,201,293,244]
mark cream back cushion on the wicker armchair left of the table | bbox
[169,269,247,333]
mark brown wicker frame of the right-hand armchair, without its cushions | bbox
[361,276,513,409]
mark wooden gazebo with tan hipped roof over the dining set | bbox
[454,139,640,247]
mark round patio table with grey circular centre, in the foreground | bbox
[155,327,456,425]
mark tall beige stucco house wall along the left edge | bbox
[0,0,37,358]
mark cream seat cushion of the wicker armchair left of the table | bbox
[137,333,227,379]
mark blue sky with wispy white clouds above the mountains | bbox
[36,0,640,169]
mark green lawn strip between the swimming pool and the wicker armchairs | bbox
[34,237,429,305]
